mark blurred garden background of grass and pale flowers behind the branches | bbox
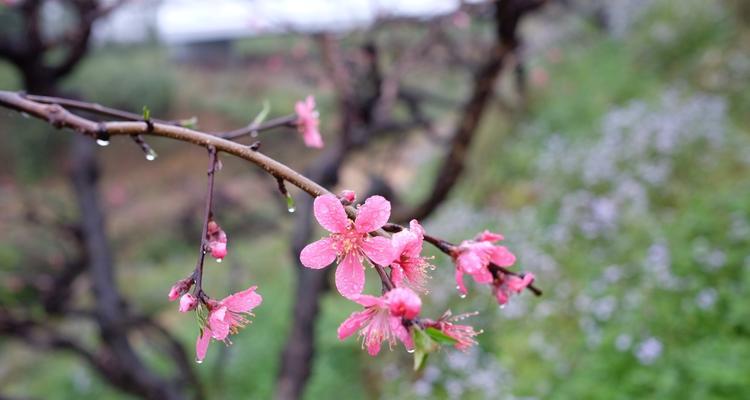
[0,0,750,399]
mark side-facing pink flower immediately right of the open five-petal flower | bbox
[391,219,430,291]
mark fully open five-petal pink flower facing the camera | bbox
[300,194,393,297]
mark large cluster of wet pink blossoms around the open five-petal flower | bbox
[300,190,534,355]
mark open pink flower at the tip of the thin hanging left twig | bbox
[195,286,263,362]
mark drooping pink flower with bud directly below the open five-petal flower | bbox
[338,288,422,356]
